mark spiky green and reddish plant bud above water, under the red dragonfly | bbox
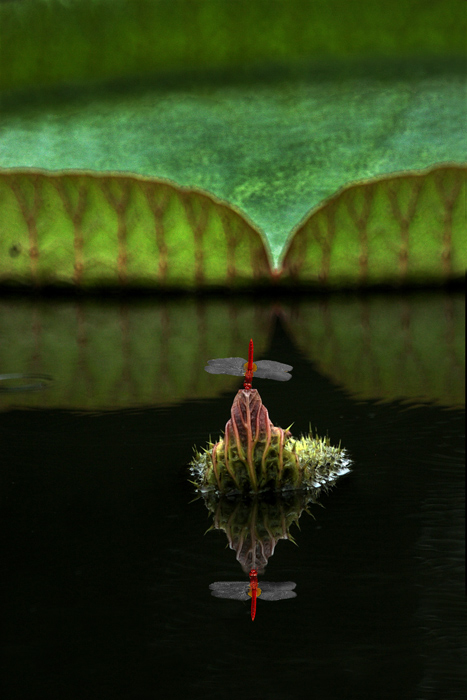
[190,389,351,495]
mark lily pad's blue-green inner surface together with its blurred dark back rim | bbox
[0,0,467,276]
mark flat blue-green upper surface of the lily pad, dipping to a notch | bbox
[0,64,467,270]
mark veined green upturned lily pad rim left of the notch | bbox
[0,169,271,289]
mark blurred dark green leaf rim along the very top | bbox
[0,0,466,90]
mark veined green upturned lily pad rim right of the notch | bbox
[281,164,467,287]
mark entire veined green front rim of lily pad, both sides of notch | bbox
[0,164,467,289]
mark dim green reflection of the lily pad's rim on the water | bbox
[0,293,465,410]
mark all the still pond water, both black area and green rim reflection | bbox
[0,291,467,700]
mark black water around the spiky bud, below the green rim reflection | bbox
[0,292,467,700]
